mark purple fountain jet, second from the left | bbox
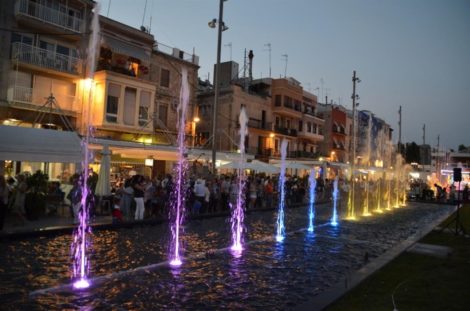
[169,68,189,267]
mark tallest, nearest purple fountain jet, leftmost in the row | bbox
[72,3,99,289]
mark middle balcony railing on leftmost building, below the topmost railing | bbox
[11,42,82,75]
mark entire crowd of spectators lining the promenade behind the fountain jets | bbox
[0,168,469,230]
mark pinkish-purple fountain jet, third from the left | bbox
[230,107,248,255]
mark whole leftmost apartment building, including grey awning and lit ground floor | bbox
[0,0,93,177]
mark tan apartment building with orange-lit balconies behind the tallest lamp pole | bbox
[197,62,324,165]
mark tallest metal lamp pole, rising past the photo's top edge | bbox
[212,0,224,175]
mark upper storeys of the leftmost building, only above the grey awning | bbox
[0,0,93,129]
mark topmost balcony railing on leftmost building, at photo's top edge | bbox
[15,0,84,32]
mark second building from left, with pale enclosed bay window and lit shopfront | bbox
[87,16,199,175]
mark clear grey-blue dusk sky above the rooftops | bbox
[100,0,470,149]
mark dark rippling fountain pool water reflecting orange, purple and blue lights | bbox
[0,204,449,310]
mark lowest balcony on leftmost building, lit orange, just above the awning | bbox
[7,85,79,114]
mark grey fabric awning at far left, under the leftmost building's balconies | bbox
[0,125,82,163]
